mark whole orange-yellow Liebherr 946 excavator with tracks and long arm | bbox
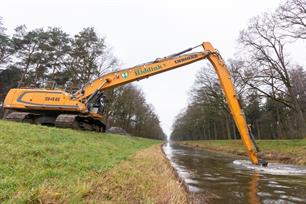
[3,42,267,166]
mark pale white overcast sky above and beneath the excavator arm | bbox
[0,0,282,137]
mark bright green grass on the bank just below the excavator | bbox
[0,121,160,203]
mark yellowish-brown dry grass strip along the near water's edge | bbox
[86,145,190,204]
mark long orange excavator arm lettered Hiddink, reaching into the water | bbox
[74,42,260,165]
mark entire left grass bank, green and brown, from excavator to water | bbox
[0,121,186,203]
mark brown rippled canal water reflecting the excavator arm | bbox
[163,143,306,204]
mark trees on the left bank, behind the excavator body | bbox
[0,18,164,139]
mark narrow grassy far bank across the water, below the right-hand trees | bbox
[180,139,306,165]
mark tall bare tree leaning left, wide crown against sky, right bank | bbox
[239,13,306,137]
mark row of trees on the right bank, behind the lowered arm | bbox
[171,0,306,140]
